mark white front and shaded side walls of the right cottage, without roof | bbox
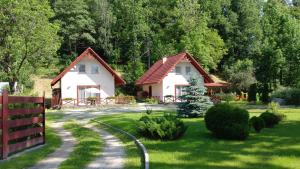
[143,60,204,101]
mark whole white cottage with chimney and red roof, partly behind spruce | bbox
[136,52,227,102]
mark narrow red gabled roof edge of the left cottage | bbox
[51,48,125,86]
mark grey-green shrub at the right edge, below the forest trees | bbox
[271,88,300,105]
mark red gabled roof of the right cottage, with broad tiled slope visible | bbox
[136,52,214,85]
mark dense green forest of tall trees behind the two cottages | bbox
[0,0,300,97]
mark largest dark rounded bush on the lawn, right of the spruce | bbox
[204,103,249,140]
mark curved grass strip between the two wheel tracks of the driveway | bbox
[59,121,103,169]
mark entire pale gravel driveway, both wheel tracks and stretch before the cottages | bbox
[30,106,170,169]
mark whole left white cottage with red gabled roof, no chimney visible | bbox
[51,48,125,106]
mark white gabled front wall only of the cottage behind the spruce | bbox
[163,61,204,96]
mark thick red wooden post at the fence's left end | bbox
[2,90,9,159]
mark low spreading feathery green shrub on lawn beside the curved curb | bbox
[138,114,187,140]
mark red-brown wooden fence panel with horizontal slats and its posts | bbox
[0,91,45,159]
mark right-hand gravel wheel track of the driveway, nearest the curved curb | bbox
[85,125,125,169]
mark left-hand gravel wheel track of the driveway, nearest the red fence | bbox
[29,122,76,169]
